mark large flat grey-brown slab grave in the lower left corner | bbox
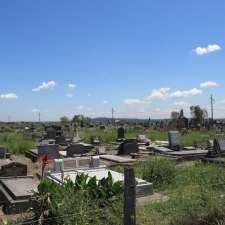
[0,176,39,214]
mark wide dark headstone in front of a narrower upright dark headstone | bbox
[118,139,139,155]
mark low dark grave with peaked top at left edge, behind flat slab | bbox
[0,159,27,177]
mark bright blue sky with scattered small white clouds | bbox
[0,0,225,121]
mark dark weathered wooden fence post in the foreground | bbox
[124,168,136,225]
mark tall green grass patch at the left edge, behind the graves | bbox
[0,133,35,155]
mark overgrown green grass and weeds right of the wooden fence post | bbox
[136,158,225,225]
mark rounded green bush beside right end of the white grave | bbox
[136,158,176,188]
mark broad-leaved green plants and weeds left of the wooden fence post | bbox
[32,173,123,225]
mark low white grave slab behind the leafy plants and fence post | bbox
[47,168,153,197]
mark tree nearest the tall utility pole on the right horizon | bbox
[190,105,208,128]
